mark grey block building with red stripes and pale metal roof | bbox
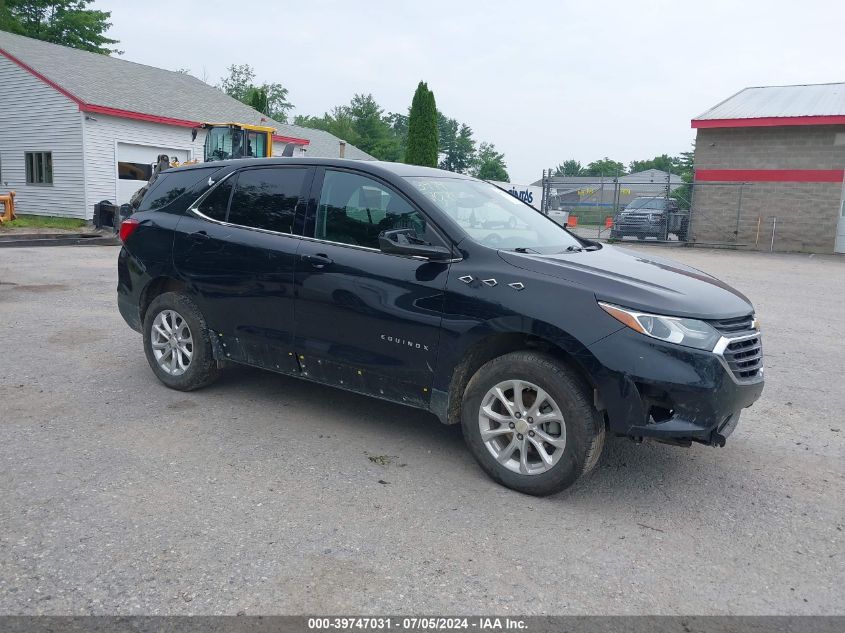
[691,83,845,253]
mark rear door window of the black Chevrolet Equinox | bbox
[227,167,309,233]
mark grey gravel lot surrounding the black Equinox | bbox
[0,247,845,614]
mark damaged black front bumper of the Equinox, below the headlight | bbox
[589,328,763,446]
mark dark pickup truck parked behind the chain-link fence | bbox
[610,196,689,242]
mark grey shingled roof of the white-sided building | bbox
[0,31,373,159]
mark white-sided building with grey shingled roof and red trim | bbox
[0,31,372,219]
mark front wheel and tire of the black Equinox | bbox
[461,351,605,496]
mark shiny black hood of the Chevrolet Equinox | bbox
[499,244,754,319]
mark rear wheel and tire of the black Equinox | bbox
[143,292,220,391]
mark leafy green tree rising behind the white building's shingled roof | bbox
[0,0,121,55]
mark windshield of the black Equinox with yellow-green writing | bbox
[406,176,583,254]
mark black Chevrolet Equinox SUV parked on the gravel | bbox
[117,158,763,495]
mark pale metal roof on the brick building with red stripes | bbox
[693,83,845,121]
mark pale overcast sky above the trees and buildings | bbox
[100,0,845,182]
